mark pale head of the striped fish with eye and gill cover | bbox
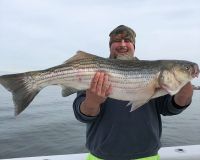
[159,61,200,95]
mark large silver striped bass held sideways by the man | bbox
[0,51,200,115]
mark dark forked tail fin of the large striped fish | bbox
[0,72,41,116]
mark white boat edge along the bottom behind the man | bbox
[1,145,200,160]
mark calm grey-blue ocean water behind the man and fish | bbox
[0,86,200,158]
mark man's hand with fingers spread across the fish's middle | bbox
[80,72,111,116]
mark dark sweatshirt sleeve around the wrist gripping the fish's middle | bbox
[73,91,97,123]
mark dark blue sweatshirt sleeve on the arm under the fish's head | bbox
[155,95,190,116]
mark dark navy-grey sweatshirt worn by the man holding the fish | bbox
[73,92,187,160]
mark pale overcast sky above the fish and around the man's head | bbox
[0,0,200,78]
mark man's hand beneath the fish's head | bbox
[174,82,193,107]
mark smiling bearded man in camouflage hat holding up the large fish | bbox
[73,25,193,160]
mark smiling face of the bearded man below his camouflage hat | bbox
[110,34,135,59]
